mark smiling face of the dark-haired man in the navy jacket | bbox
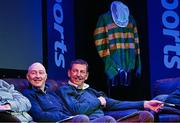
[68,64,88,85]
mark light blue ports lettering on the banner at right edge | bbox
[161,0,180,69]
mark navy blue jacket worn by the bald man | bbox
[23,85,70,122]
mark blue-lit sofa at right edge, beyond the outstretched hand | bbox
[153,77,180,122]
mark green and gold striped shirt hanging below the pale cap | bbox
[94,11,141,79]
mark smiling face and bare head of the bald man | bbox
[27,63,47,88]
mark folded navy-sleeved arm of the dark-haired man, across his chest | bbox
[58,85,101,115]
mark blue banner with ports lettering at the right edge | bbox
[148,0,180,94]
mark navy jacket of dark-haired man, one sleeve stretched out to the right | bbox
[58,84,144,120]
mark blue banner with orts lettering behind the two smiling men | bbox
[47,0,75,79]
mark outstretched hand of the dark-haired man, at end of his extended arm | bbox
[144,100,164,112]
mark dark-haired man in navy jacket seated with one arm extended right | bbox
[58,59,163,122]
